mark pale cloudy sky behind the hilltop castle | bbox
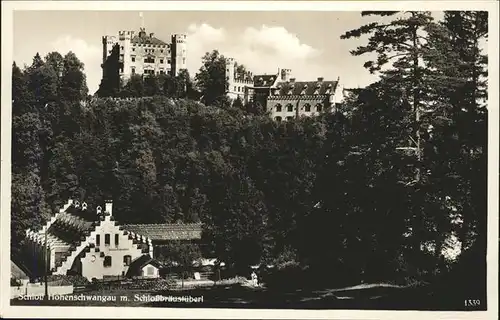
[13,10,442,93]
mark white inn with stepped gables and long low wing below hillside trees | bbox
[23,200,201,280]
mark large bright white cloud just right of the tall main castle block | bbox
[188,24,324,79]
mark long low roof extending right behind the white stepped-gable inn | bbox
[123,223,202,241]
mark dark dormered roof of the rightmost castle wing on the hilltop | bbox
[275,81,338,95]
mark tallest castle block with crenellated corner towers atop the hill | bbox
[102,28,187,80]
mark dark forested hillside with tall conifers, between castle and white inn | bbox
[11,12,487,288]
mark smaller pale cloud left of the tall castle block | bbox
[50,36,102,94]
